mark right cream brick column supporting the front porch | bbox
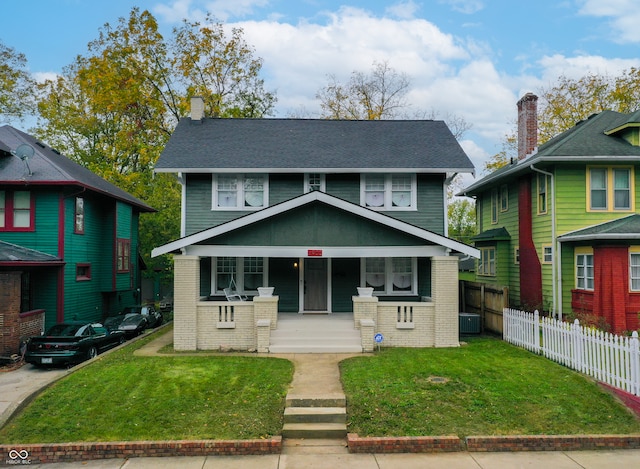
[431,256,460,347]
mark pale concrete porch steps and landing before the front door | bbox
[269,313,362,353]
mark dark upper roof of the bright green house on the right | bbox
[457,111,640,196]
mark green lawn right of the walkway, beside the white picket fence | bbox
[341,338,640,437]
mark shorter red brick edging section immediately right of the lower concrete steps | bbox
[347,433,464,453]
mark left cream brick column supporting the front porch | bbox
[173,255,200,350]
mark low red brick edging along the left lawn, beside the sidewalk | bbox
[0,436,282,466]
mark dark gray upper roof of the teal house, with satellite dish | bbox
[0,125,155,212]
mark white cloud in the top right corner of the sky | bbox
[578,0,640,43]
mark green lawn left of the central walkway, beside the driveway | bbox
[0,330,293,443]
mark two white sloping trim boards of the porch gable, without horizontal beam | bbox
[151,191,480,257]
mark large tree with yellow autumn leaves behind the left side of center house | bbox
[36,8,275,276]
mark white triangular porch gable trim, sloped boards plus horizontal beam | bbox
[151,191,479,258]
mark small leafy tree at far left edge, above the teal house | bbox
[0,42,35,121]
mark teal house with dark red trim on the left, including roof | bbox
[0,125,153,352]
